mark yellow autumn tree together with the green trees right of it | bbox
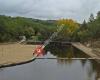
[58,11,100,43]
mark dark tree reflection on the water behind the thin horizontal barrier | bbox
[45,45,89,58]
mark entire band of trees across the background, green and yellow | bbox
[0,11,100,42]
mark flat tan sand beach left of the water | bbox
[0,44,36,65]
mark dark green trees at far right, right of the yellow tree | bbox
[76,11,100,42]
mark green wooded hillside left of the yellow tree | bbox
[0,15,55,42]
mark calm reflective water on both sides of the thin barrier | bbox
[0,46,100,80]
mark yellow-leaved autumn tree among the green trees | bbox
[57,19,79,41]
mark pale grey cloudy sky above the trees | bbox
[0,0,100,22]
